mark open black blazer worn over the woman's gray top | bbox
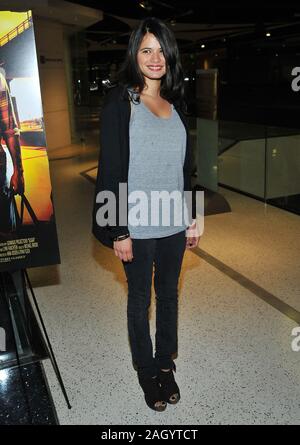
[92,86,196,248]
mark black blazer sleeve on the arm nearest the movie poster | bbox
[94,96,129,239]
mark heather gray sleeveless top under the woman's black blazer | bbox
[128,101,187,239]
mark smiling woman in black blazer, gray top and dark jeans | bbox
[93,18,199,411]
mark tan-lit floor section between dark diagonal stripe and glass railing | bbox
[201,188,300,311]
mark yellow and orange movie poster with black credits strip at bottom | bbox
[0,11,60,271]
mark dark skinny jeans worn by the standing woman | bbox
[123,231,186,376]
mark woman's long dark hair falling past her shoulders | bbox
[118,17,184,103]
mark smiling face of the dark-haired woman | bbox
[137,32,166,79]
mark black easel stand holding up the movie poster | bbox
[0,269,71,409]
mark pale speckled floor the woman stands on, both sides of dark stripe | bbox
[26,139,300,425]
